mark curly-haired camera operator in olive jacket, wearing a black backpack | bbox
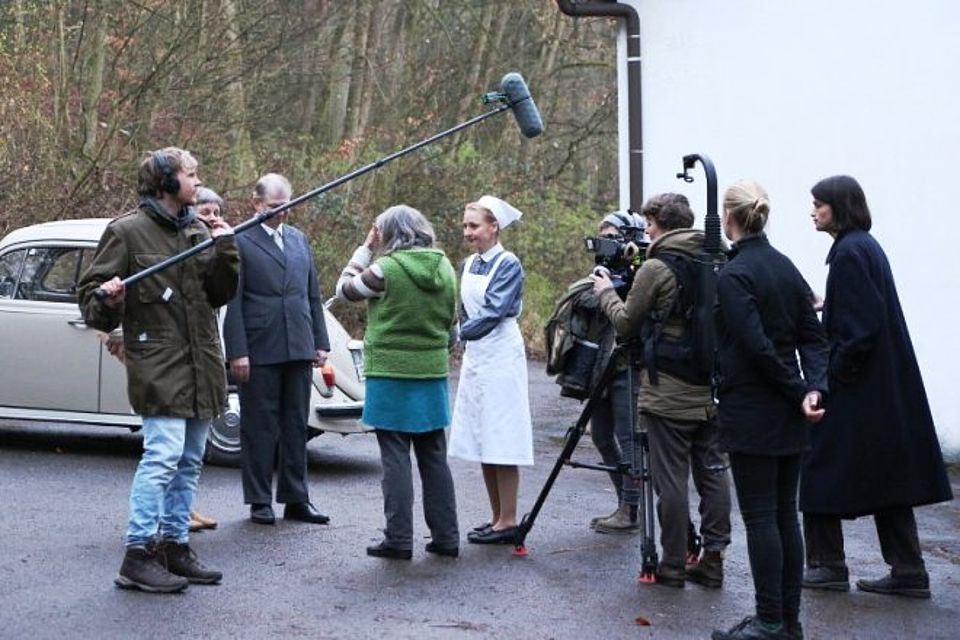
[593,193,730,588]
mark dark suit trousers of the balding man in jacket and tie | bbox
[240,361,312,504]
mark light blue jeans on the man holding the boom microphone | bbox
[127,416,210,547]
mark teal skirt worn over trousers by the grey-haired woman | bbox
[361,378,450,433]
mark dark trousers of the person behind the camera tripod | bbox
[590,370,643,506]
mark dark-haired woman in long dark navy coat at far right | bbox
[800,176,952,598]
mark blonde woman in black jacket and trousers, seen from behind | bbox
[713,180,828,640]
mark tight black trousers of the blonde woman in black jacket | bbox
[730,453,803,623]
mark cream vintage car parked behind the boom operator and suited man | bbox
[0,218,369,464]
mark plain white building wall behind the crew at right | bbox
[619,0,960,460]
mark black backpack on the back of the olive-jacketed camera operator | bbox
[641,252,725,385]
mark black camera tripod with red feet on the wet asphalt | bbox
[514,344,668,583]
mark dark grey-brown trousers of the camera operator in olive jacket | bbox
[640,413,730,571]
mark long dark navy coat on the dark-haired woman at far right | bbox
[800,231,952,517]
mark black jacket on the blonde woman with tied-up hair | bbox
[716,235,828,456]
